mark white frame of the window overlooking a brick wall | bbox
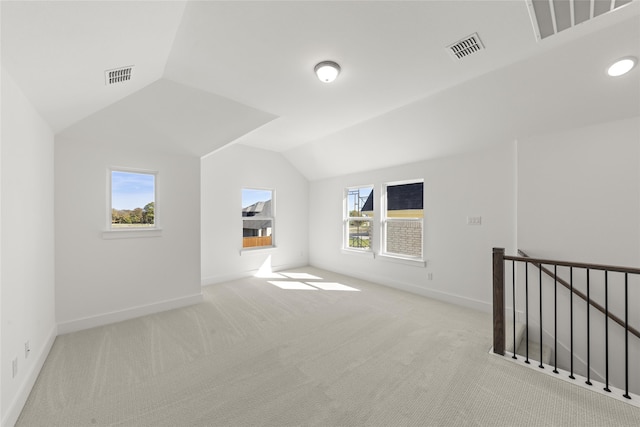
[380,178,426,266]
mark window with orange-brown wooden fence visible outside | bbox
[242,188,274,248]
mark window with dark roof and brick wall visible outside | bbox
[382,181,424,259]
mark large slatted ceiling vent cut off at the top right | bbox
[527,0,632,41]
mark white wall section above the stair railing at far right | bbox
[518,118,640,265]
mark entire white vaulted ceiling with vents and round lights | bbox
[1,0,640,179]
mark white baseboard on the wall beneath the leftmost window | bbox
[58,293,203,335]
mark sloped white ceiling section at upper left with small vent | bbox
[0,1,184,132]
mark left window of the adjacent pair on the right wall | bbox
[344,185,373,251]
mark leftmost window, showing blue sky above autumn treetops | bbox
[110,169,158,230]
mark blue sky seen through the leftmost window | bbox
[111,171,155,210]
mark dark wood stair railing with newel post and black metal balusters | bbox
[493,248,640,399]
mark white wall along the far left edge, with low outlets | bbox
[0,69,56,426]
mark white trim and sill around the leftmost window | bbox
[102,166,162,239]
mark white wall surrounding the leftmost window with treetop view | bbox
[55,109,202,333]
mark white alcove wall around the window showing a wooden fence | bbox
[202,144,309,285]
